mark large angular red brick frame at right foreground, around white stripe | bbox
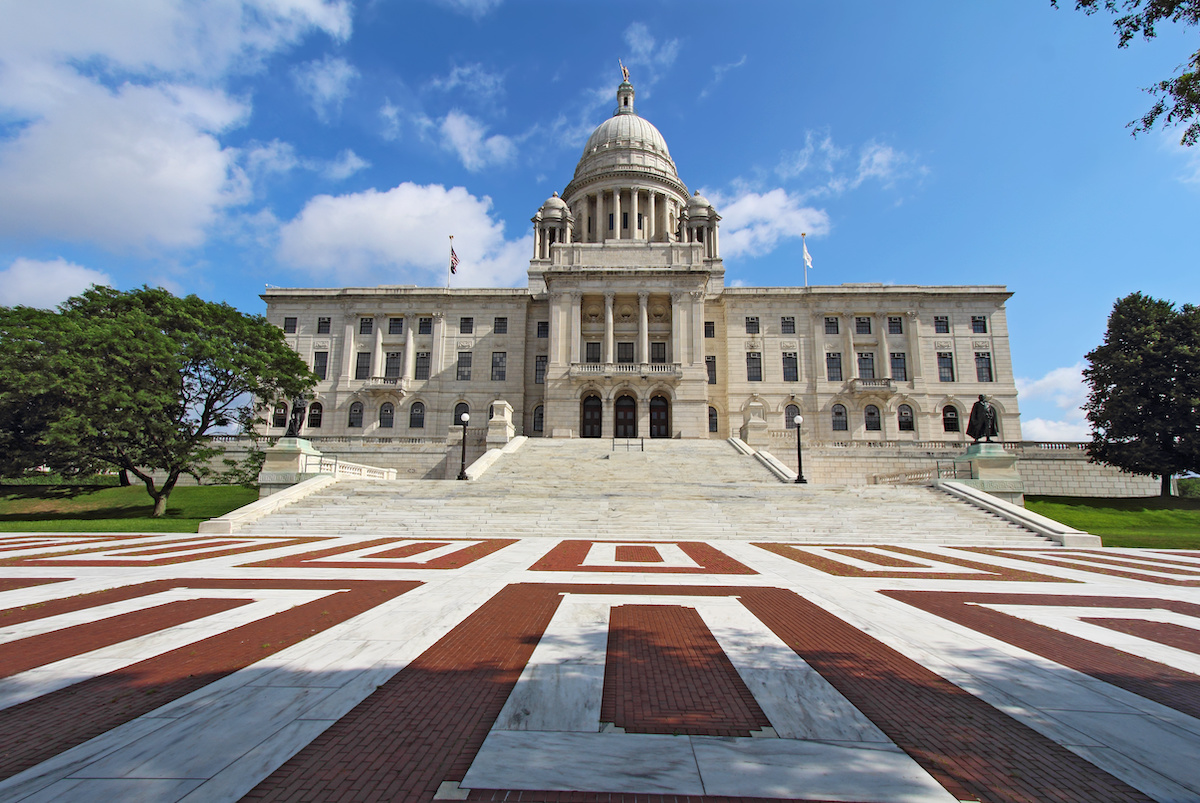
[882,591,1200,717]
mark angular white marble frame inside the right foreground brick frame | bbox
[983,603,1200,675]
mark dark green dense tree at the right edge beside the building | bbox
[1084,293,1200,496]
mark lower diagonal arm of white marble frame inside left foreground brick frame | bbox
[0,589,336,711]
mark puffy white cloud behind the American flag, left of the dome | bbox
[277,182,533,287]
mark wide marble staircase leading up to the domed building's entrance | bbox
[238,439,1050,546]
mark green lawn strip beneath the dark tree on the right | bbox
[1025,496,1200,550]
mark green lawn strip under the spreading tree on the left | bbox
[0,485,258,533]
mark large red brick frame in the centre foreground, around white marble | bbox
[244,585,1150,803]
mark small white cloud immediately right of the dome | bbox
[703,188,829,257]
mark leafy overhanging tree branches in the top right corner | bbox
[1050,0,1200,146]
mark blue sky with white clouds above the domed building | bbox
[0,0,1200,439]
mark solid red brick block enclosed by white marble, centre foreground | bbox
[600,605,770,736]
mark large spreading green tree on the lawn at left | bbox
[0,287,317,516]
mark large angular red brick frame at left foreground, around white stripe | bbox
[0,580,420,778]
